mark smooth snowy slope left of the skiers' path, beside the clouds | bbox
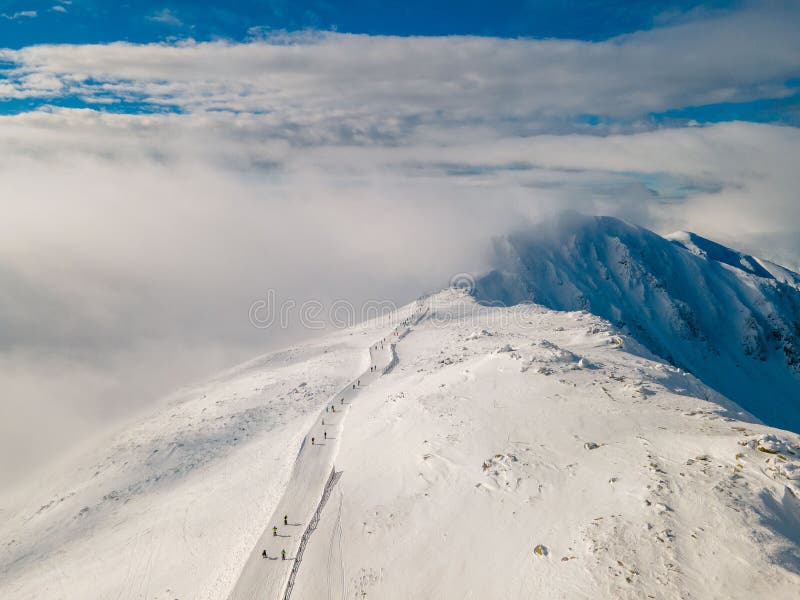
[0,314,406,600]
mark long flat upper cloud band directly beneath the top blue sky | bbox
[3,3,800,122]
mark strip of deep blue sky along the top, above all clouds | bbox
[0,0,742,48]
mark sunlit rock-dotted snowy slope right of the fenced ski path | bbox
[292,292,800,600]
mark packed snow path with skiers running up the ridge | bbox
[229,311,425,600]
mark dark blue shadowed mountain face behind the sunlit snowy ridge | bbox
[474,213,800,431]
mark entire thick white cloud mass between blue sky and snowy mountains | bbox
[0,2,800,490]
